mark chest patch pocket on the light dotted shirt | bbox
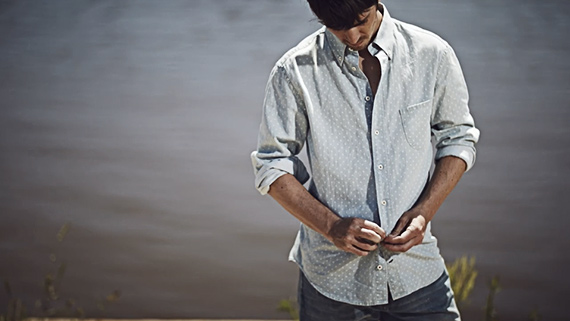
[400,99,432,149]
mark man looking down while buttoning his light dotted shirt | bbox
[251,0,479,321]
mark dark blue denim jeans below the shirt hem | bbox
[298,272,461,321]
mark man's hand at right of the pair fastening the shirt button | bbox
[383,208,428,252]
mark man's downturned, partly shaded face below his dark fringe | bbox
[328,5,382,50]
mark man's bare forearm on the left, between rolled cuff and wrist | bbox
[268,174,340,240]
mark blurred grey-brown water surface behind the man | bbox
[0,0,570,320]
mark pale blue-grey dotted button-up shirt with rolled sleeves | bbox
[251,7,479,305]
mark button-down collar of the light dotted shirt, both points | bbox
[325,4,395,65]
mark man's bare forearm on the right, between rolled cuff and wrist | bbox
[414,156,467,222]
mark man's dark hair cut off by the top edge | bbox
[307,0,378,30]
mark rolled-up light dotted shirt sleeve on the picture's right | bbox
[431,45,479,171]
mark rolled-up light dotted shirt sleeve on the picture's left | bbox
[251,65,309,194]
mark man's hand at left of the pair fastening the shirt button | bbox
[327,217,386,256]
